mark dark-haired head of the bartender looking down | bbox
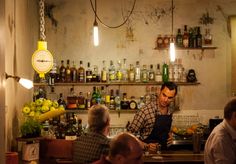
[158,82,177,107]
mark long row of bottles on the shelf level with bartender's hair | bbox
[35,59,190,85]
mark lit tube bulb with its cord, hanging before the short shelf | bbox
[170,0,175,62]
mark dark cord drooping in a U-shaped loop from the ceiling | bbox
[90,0,136,28]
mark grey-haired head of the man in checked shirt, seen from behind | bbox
[88,105,110,135]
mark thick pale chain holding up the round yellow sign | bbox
[39,0,46,41]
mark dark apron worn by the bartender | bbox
[143,114,172,150]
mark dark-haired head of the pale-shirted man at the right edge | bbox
[224,99,236,130]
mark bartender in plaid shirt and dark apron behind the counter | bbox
[127,82,177,152]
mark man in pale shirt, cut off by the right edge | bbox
[204,99,236,164]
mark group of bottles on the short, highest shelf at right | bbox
[156,25,212,48]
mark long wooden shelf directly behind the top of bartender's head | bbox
[34,82,200,86]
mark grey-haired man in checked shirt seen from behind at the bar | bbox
[73,105,110,164]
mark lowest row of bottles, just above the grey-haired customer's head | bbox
[42,85,160,110]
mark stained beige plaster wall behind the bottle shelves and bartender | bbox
[43,0,236,123]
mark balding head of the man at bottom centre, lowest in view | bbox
[109,133,143,164]
